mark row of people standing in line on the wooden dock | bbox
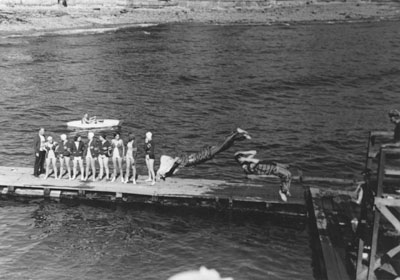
[33,128,156,185]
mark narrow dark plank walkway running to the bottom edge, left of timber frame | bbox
[310,187,350,280]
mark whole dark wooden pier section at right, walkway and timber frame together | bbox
[309,131,400,280]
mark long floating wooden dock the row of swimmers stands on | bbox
[0,166,306,216]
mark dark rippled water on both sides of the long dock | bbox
[0,22,400,279]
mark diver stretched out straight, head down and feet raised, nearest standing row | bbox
[157,128,251,180]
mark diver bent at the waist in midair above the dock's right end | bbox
[235,150,292,202]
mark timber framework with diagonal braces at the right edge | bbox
[356,131,400,280]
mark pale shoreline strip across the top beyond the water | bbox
[0,2,400,37]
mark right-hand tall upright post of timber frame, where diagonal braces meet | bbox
[367,148,386,280]
